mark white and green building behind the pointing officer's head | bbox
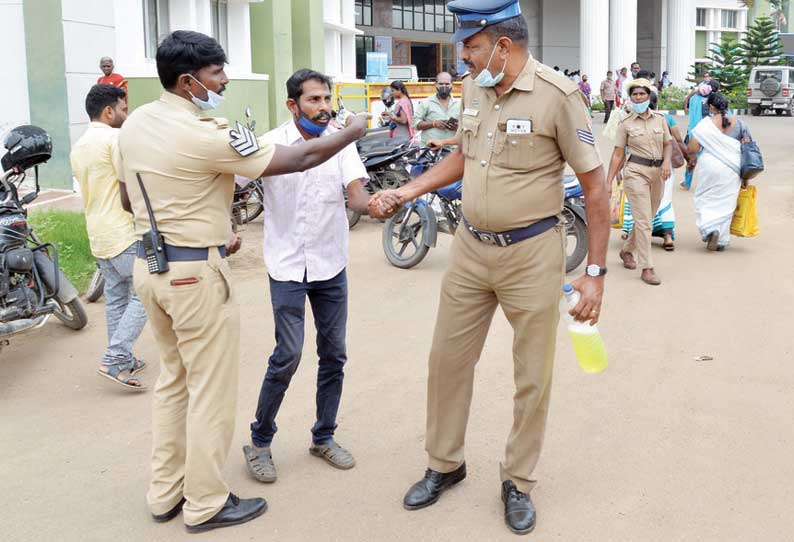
[0,0,358,188]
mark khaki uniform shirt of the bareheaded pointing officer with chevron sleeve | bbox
[119,91,275,247]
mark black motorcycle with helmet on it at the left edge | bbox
[0,126,88,348]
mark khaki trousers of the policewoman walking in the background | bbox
[623,162,664,269]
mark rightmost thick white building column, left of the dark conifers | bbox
[667,0,696,86]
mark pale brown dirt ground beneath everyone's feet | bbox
[0,118,794,542]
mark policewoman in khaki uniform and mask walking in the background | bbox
[607,79,673,286]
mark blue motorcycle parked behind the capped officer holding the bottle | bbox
[382,148,588,273]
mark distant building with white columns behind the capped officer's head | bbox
[356,0,716,89]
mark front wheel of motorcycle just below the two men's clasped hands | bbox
[383,205,433,269]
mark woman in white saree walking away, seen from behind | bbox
[689,92,750,250]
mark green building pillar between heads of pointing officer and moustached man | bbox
[250,0,294,126]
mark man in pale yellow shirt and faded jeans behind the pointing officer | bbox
[71,85,146,391]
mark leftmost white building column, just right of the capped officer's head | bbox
[579,0,609,85]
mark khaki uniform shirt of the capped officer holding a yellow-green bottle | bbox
[458,57,601,232]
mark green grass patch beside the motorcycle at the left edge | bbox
[28,209,96,294]
